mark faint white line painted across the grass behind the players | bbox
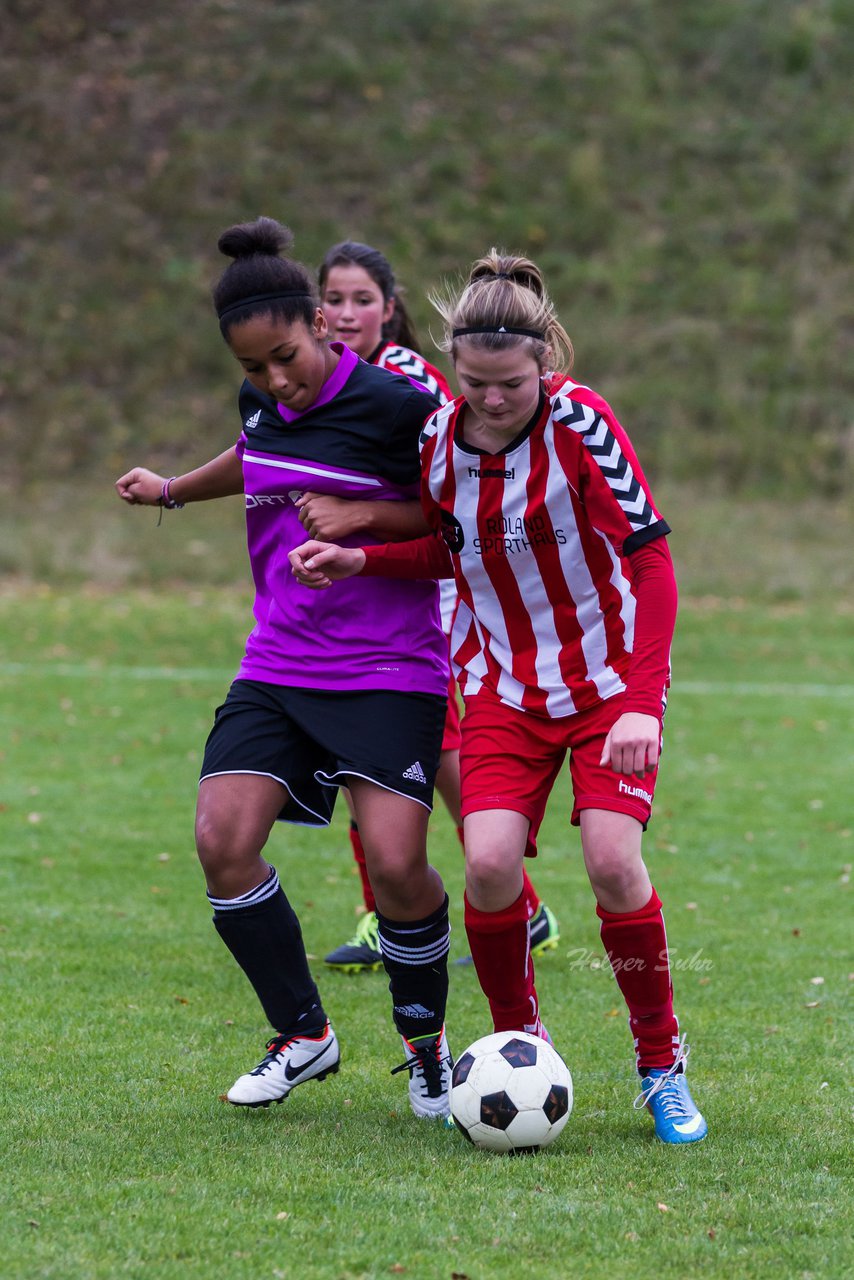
[0,662,854,699]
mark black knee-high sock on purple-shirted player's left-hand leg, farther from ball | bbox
[207,868,326,1032]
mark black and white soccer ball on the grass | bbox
[451,1032,572,1153]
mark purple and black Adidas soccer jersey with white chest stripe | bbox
[237,343,448,695]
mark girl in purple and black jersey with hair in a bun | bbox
[117,218,452,1117]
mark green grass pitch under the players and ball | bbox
[0,573,854,1280]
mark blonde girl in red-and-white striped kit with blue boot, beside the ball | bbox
[291,250,707,1143]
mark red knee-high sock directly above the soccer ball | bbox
[465,890,539,1032]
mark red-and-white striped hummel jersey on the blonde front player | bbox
[421,375,670,717]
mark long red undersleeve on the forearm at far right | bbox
[625,538,677,719]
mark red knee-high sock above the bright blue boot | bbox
[597,890,679,1073]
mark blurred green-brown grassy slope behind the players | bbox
[0,0,854,498]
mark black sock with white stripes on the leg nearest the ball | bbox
[378,896,451,1041]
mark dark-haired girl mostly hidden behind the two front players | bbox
[298,241,560,973]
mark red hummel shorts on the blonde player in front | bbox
[460,691,658,858]
